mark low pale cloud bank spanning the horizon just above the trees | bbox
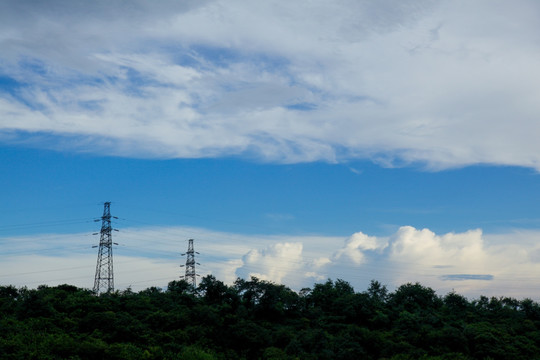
[0,226,540,298]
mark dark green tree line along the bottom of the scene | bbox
[0,275,540,360]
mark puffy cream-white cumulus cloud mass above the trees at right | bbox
[228,226,540,298]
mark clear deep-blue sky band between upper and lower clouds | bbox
[1,146,540,236]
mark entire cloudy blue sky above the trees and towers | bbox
[0,0,540,300]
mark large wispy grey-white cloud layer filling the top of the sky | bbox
[0,0,540,169]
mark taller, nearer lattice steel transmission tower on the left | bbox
[93,201,118,295]
